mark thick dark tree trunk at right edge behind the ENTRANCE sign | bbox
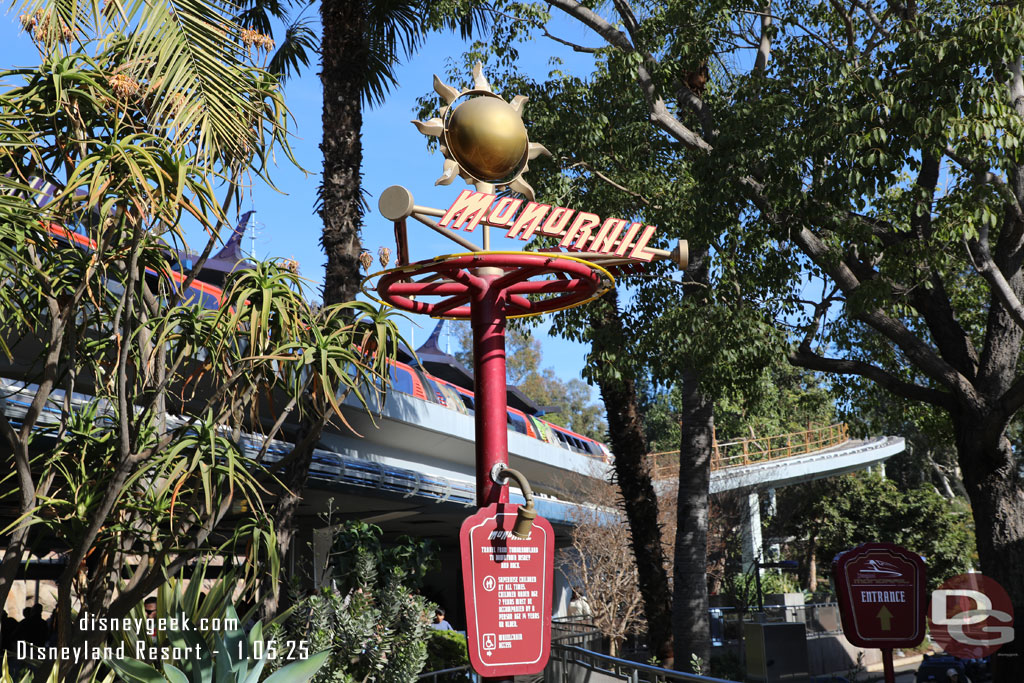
[953,416,1024,683]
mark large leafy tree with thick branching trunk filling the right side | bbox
[444,0,1024,682]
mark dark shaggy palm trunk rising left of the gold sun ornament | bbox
[319,0,368,304]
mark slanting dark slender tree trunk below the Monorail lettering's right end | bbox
[592,291,674,667]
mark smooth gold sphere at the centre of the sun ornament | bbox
[444,95,529,182]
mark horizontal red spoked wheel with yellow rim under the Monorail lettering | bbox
[364,252,615,319]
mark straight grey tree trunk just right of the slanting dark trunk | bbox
[672,369,715,673]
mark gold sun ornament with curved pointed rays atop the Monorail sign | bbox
[413,62,551,202]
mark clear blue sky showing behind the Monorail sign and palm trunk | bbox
[0,12,595,389]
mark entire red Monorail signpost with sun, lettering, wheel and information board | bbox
[364,63,687,681]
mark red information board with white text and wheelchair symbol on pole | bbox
[459,503,555,677]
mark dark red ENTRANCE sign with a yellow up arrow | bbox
[833,543,928,649]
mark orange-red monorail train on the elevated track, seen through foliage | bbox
[32,205,611,462]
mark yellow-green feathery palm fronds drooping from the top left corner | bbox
[16,0,291,179]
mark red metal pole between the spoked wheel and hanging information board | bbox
[470,270,509,508]
